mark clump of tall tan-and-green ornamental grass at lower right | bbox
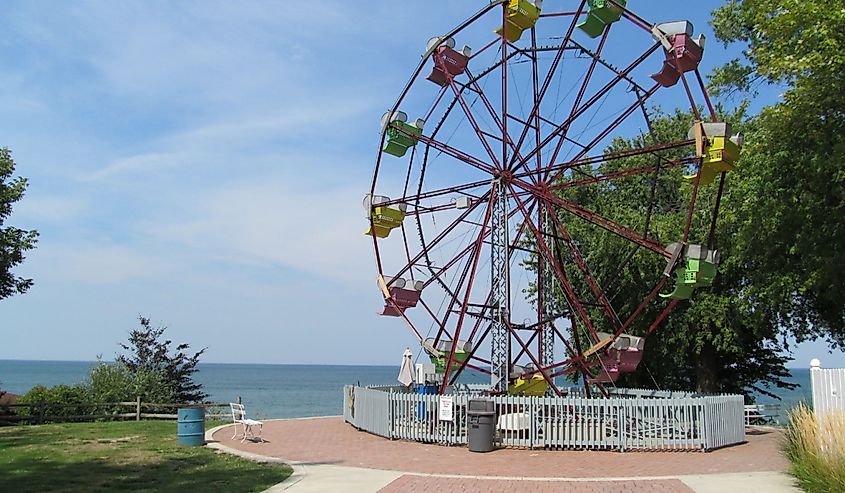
[785,404,845,493]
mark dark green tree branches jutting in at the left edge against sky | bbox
[0,147,38,300]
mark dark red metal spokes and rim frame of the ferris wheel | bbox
[365,0,741,395]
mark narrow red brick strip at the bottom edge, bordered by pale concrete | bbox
[379,476,692,493]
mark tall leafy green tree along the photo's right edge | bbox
[712,0,845,348]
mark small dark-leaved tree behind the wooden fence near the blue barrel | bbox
[115,316,208,403]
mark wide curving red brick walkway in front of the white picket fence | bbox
[208,417,788,476]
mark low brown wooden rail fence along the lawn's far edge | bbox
[0,398,232,424]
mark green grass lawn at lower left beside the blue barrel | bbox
[0,421,291,493]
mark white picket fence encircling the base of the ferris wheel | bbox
[343,386,745,451]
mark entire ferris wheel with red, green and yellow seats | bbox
[364,0,742,395]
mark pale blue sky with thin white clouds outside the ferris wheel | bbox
[0,0,845,366]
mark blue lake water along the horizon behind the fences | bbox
[0,360,812,418]
